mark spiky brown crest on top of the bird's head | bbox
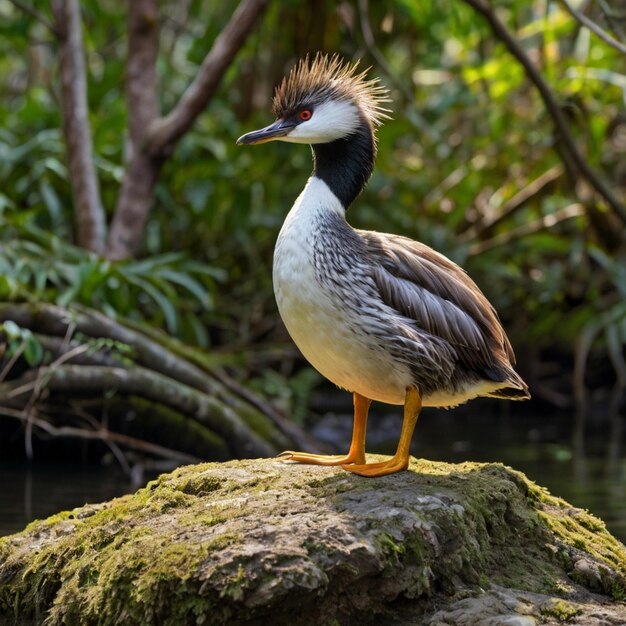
[273,52,390,126]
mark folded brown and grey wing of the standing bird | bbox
[358,231,515,369]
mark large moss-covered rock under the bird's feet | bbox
[0,460,626,626]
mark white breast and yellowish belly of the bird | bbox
[273,177,411,404]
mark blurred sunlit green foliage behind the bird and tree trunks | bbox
[0,0,626,394]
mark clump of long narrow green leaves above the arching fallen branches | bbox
[0,219,224,345]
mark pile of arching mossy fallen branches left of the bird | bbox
[0,303,318,460]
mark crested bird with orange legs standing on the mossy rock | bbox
[237,52,530,477]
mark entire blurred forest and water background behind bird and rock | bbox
[0,0,626,540]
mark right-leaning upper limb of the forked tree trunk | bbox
[147,0,269,156]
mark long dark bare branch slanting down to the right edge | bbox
[463,0,626,224]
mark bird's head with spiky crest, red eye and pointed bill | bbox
[237,53,388,145]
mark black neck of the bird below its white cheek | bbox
[312,121,376,209]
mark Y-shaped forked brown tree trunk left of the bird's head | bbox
[107,0,269,259]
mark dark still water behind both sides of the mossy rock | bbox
[0,411,626,542]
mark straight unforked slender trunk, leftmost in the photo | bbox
[52,0,106,254]
